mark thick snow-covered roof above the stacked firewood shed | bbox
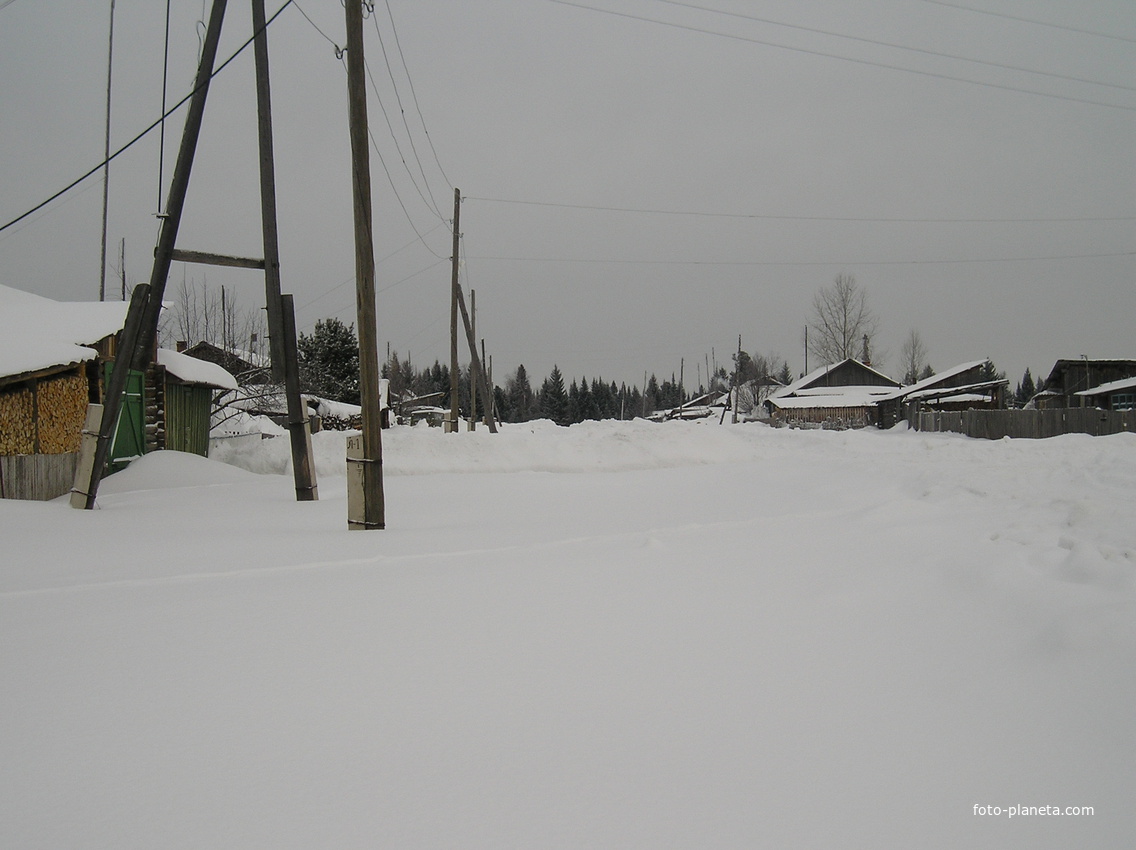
[0,285,128,376]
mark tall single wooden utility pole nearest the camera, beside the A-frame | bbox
[344,0,383,528]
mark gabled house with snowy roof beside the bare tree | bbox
[765,358,900,428]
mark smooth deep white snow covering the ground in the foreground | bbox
[0,422,1136,850]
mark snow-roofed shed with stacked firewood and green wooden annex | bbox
[0,286,236,499]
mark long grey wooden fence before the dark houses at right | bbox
[911,408,1136,440]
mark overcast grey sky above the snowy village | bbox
[0,0,1136,386]
